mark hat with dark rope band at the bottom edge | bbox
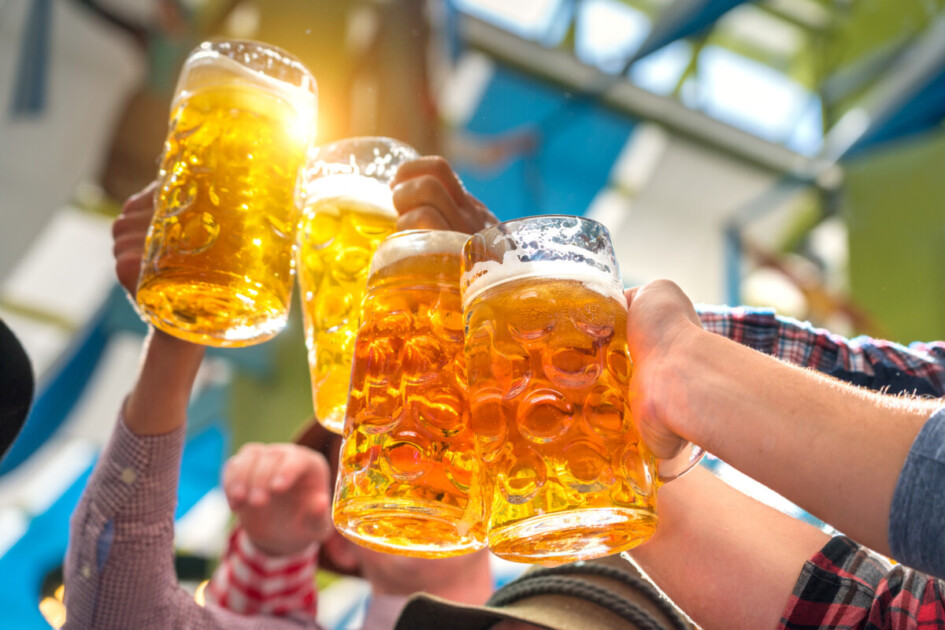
[396,555,695,630]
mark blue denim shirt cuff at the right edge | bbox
[889,408,945,578]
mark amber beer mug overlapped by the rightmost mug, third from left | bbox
[332,230,486,558]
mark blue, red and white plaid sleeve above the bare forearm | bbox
[696,305,945,397]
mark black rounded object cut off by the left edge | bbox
[0,320,34,460]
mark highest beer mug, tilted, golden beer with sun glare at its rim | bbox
[137,41,317,347]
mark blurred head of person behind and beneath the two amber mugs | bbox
[295,419,489,599]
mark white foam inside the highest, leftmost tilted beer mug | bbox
[171,49,317,120]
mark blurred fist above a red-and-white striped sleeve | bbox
[223,443,333,556]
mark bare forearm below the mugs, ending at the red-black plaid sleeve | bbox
[631,467,828,630]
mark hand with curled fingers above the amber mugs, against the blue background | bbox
[391,156,498,234]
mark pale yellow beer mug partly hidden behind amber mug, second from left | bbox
[298,138,419,433]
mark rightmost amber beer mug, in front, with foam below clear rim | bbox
[461,216,701,563]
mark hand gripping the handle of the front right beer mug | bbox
[626,280,702,459]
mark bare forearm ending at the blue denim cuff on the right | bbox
[662,330,940,553]
